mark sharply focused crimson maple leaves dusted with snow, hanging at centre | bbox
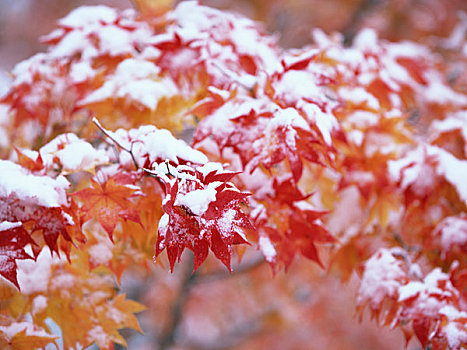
[154,163,253,270]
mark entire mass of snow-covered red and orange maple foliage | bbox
[0,2,467,349]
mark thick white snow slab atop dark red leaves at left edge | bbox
[0,160,70,207]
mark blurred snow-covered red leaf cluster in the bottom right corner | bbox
[358,248,467,349]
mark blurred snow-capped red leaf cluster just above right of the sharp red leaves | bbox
[194,96,338,182]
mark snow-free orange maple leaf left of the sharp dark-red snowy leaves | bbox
[72,178,141,240]
